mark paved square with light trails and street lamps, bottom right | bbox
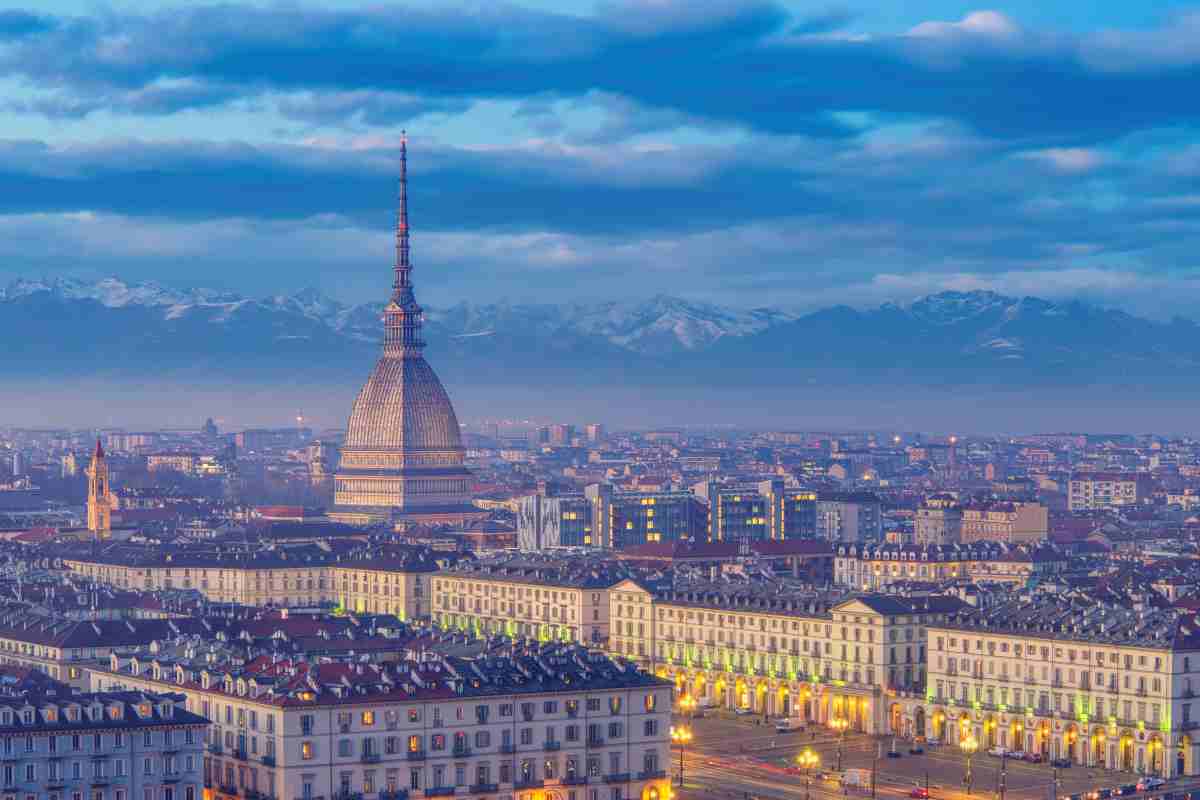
[668,716,1171,800]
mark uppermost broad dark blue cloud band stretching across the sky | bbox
[0,0,1200,146]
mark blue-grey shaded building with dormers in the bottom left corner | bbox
[0,692,208,800]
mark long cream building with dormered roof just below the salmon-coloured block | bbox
[834,541,1069,591]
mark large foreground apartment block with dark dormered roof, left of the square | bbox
[92,644,671,800]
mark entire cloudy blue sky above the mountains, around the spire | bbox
[0,0,1200,317]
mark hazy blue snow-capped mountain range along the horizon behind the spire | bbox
[7,277,1200,386]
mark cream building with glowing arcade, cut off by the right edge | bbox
[912,597,1200,777]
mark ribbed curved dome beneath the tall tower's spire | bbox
[343,355,462,451]
